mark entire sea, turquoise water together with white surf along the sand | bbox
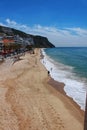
[41,47,87,110]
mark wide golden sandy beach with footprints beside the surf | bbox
[0,49,84,130]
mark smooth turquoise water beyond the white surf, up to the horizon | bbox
[45,47,87,78]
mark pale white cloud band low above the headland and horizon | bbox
[1,18,87,46]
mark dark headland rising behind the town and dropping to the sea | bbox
[0,26,55,48]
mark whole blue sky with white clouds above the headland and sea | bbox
[0,0,87,47]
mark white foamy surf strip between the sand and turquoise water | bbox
[41,50,86,110]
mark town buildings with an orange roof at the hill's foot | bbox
[0,34,34,59]
